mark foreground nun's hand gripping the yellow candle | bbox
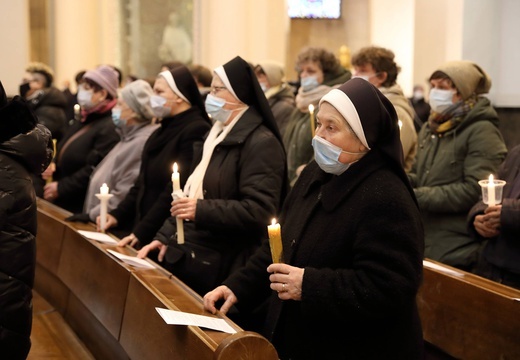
[267,263,305,301]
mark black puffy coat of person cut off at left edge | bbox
[0,125,52,360]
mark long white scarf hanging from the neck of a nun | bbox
[184,107,248,199]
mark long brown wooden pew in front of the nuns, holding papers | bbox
[35,199,278,360]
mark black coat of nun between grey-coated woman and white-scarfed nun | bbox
[110,107,211,245]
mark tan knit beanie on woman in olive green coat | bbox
[434,60,491,100]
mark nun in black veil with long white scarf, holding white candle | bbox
[138,57,287,294]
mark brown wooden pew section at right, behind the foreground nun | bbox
[418,260,520,360]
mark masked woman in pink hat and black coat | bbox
[43,65,119,213]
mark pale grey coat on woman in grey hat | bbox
[83,123,157,222]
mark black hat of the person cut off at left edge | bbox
[0,81,38,143]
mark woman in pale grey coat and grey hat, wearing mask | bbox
[68,80,157,226]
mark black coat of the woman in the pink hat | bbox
[54,111,119,213]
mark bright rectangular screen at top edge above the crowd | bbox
[287,0,341,19]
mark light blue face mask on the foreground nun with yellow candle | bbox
[312,135,366,175]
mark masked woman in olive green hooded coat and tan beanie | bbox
[409,61,507,271]
